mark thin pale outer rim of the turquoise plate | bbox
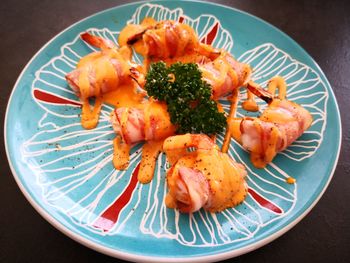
[4,0,342,262]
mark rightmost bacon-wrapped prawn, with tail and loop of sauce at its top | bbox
[231,77,312,168]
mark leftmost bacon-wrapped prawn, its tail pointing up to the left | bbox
[66,33,139,100]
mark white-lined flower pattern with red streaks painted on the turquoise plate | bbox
[21,3,328,247]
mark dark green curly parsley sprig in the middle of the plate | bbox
[145,62,226,134]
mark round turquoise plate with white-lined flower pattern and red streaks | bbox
[5,1,341,262]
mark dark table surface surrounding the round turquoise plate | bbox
[0,0,350,263]
